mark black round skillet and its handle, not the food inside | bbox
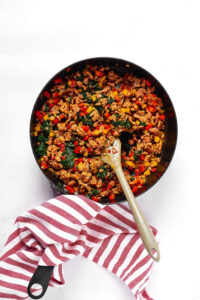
[28,57,178,299]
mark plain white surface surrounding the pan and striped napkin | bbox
[0,0,200,300]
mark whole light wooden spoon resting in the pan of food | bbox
[101,139,160,261]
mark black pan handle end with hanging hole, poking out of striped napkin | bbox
[27,266,54,299]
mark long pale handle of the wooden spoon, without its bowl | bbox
[114,165,160,261]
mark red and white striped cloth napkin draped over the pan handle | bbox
[0,195,157,300]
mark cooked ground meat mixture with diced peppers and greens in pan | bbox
[33,65,165,202]
